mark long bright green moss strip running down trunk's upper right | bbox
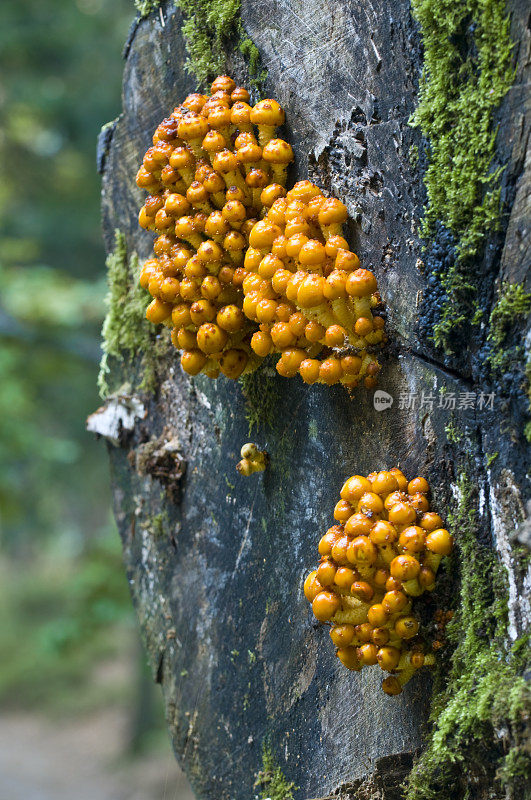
[410,0,514,352]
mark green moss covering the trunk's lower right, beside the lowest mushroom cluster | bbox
[405,471,531,800]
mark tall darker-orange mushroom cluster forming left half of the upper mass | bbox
[136,75,293,379]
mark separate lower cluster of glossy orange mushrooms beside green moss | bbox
[304,468,453,695]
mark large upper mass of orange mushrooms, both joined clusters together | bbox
[136,75,385,388]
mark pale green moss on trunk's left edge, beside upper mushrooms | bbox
[98,229,168,398]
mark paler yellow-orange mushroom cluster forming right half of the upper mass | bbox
[243,181,385,388]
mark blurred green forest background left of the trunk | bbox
[0,0,193,800]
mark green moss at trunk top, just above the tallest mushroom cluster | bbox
[176,0,266,88]
